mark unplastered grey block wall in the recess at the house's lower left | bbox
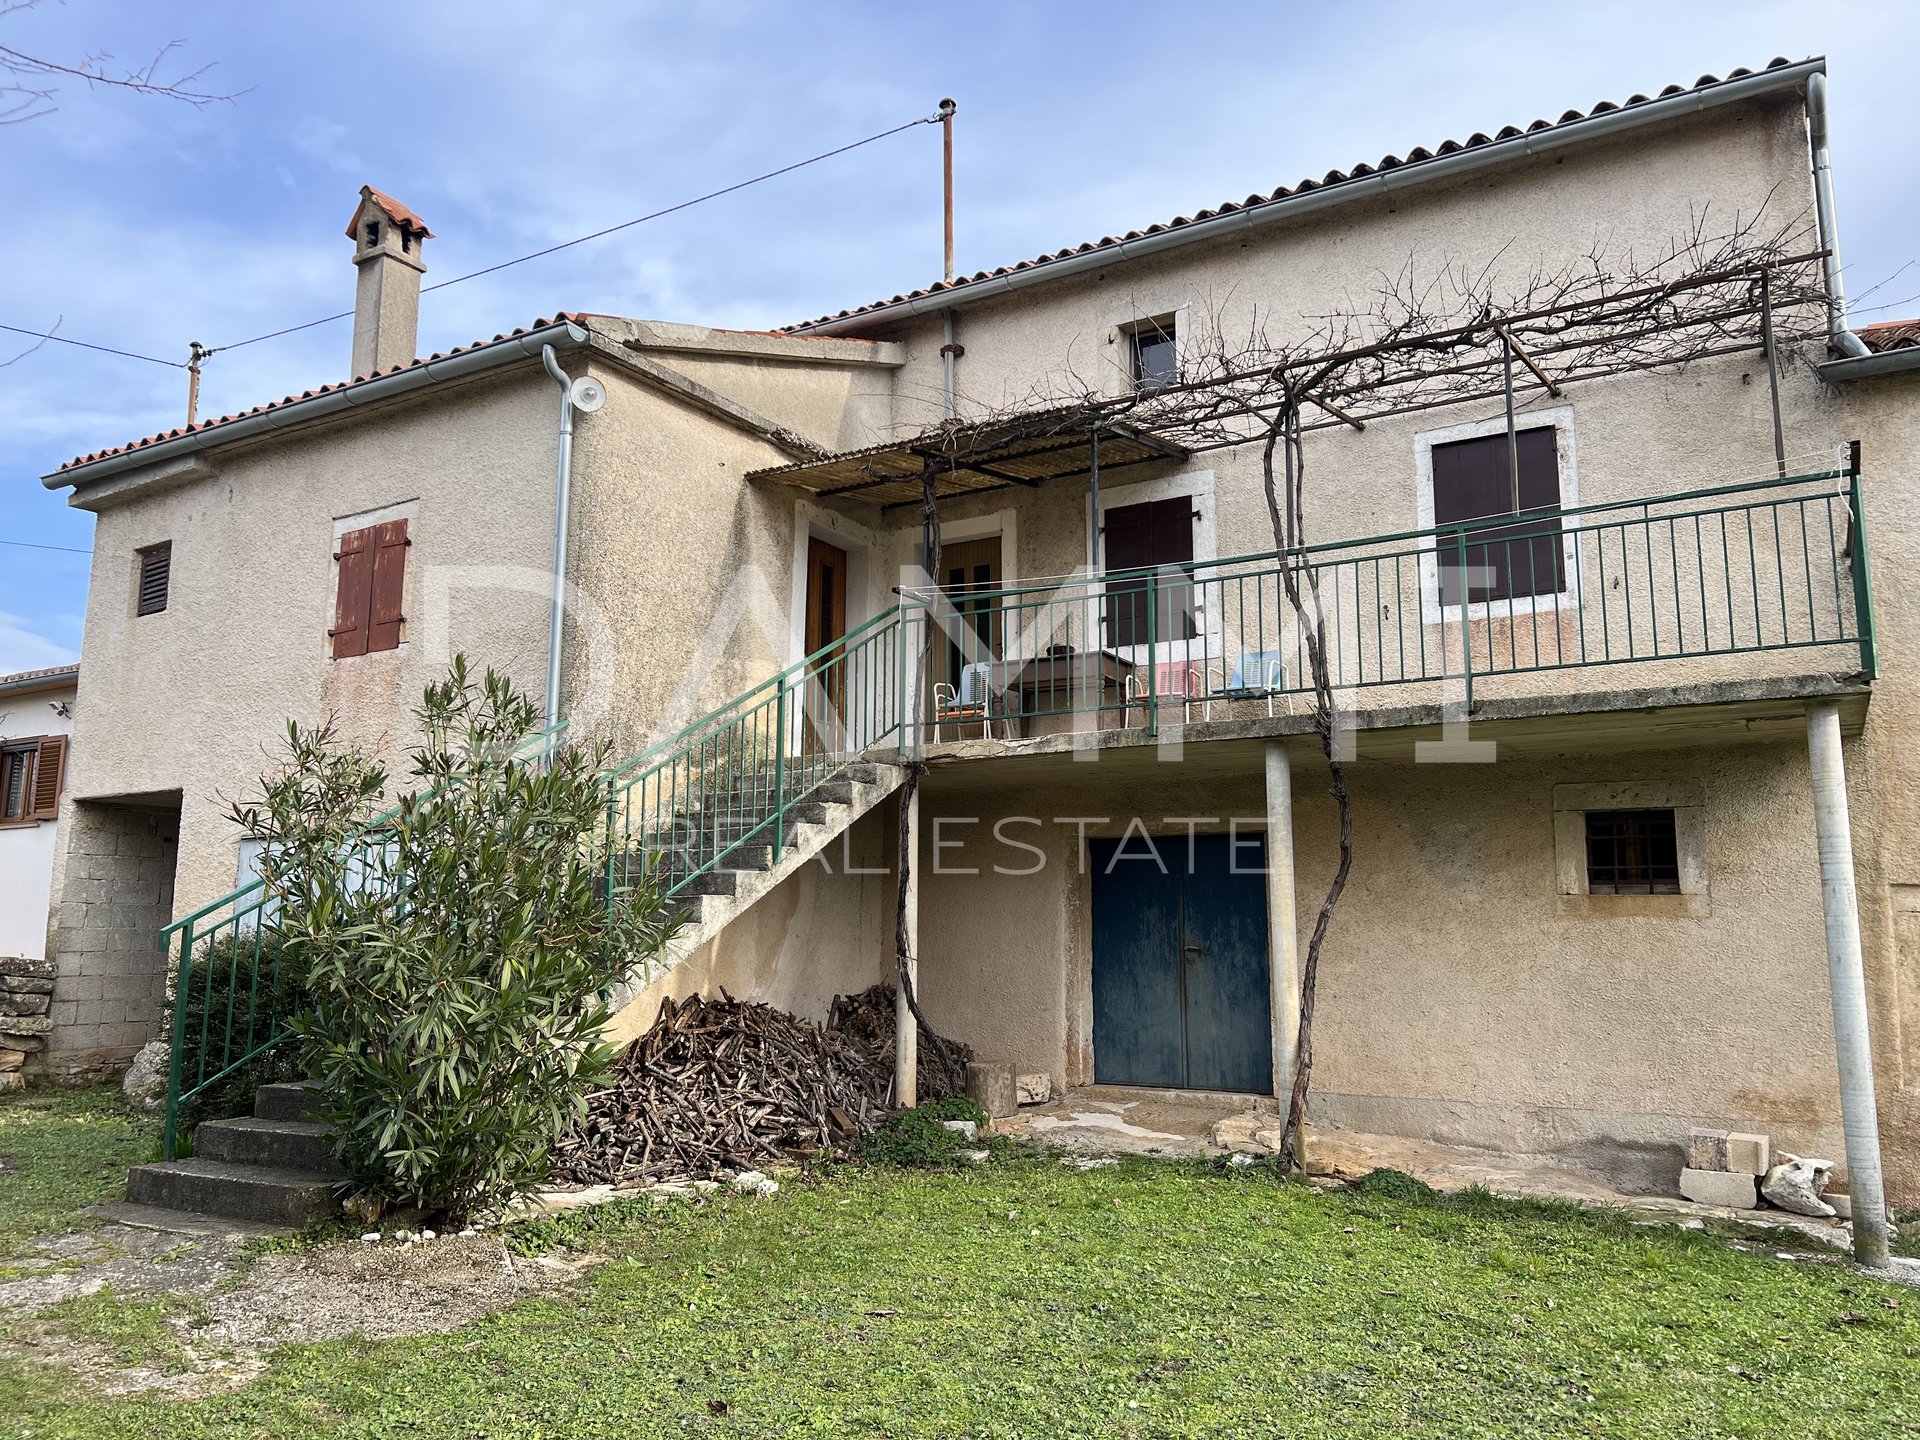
[36,801,180,1077]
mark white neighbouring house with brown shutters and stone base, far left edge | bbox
[0,664,81,1089]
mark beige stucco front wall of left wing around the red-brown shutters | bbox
[56,367,557,1048]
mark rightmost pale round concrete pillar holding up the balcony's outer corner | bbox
[1807,705,1887,1265]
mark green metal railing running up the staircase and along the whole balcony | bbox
[159,449,1876,1154]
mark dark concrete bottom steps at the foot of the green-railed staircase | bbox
[127,1085,342,1229]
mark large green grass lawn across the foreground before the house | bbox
[0,1158,1920,1440]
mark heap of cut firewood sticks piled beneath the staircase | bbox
[553,985,973,1187]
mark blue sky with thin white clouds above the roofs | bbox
[0,0,1920,672]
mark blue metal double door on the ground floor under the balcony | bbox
[1089,833,1273,1094]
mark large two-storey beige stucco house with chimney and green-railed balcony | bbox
[26,61,1920,1228]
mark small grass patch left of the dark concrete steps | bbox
[0,1085,159,1273]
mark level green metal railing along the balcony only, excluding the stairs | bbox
[906,463,1876,739]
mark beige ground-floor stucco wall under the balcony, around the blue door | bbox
[920,745,1841,1179]
